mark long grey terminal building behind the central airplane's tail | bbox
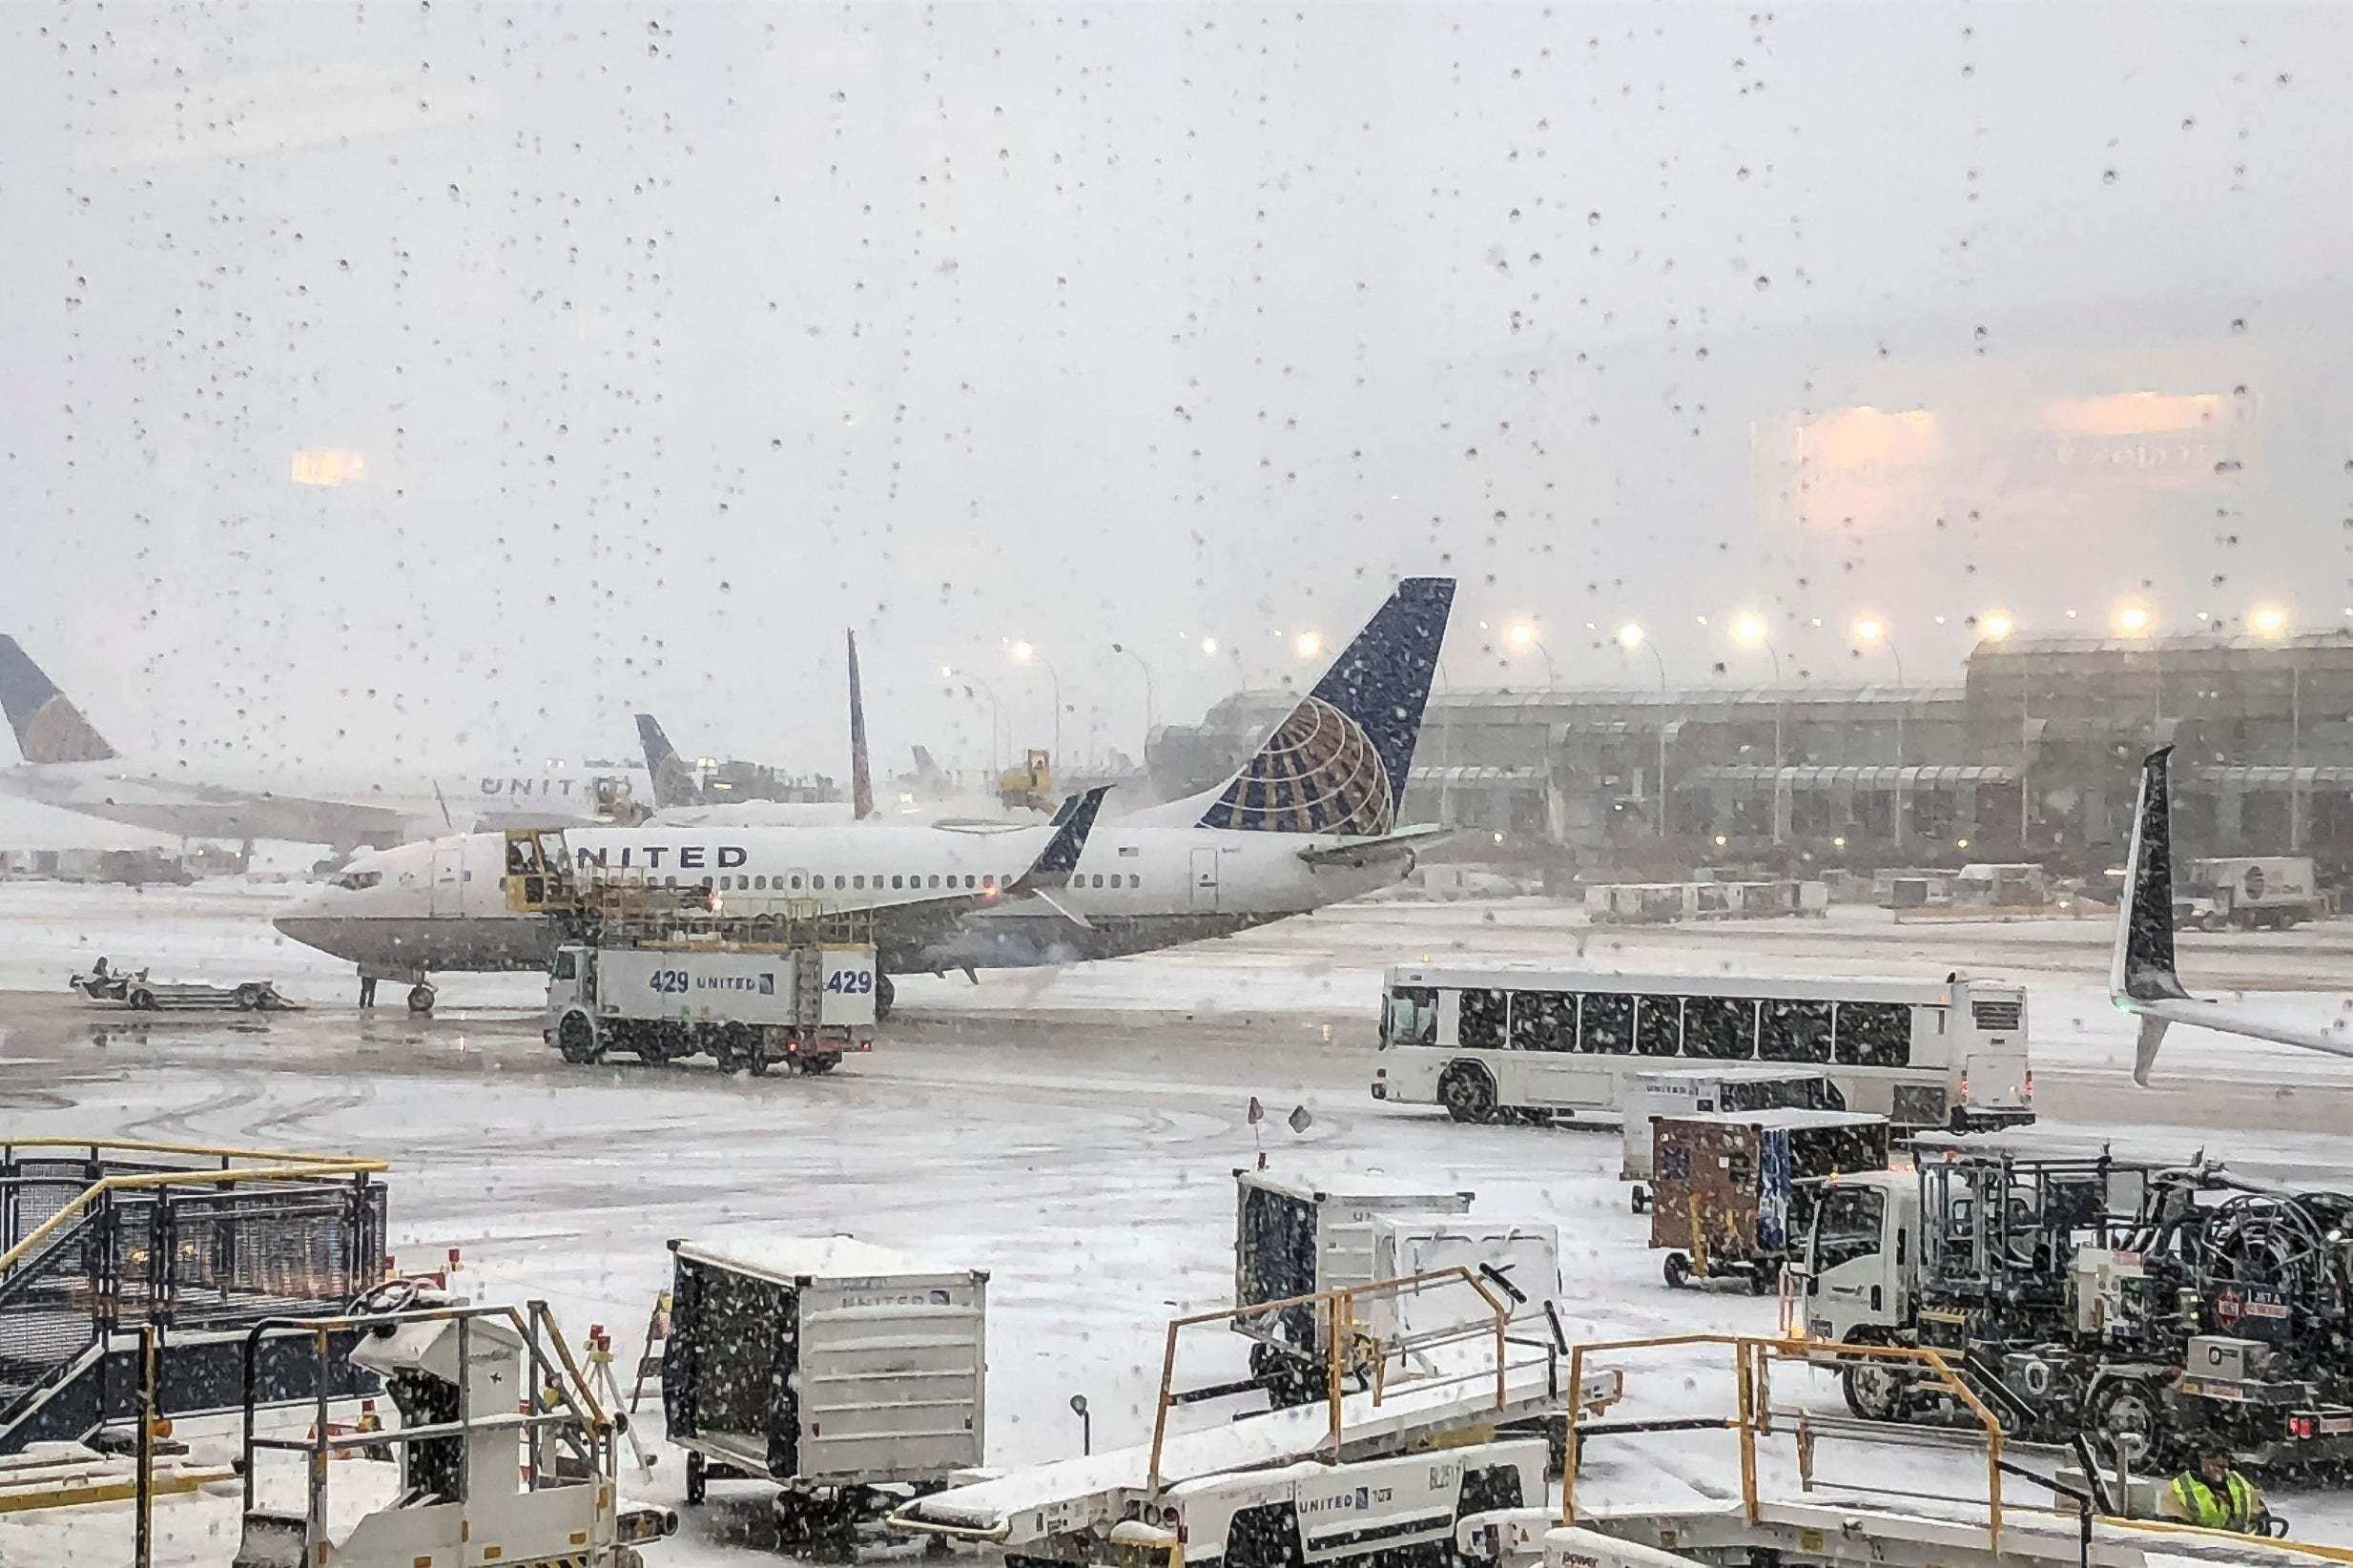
[1148,631,2353,880]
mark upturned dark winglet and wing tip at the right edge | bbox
[2108,747,2353,1087]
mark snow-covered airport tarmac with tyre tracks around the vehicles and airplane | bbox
[0,883,2353,1568]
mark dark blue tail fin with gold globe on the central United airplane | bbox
[1157,577,1455,834]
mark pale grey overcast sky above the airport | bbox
[0,0,2353,773]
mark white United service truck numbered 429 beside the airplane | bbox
[546,941,876,1074]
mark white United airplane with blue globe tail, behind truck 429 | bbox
[276,577,1455,1012]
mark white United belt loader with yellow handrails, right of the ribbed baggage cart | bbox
[890,1265,1623,1563]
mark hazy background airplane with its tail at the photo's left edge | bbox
[0,635,651,853]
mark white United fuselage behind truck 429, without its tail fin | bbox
[278,819,1412,980]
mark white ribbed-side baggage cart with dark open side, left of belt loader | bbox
[661,1236,988,1549]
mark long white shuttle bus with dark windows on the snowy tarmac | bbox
[1372,965,2035,1137]
